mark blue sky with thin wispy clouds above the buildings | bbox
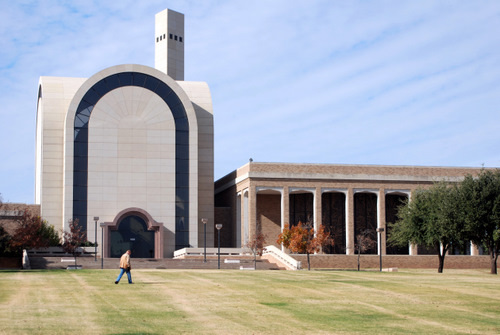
[0,0,500,203]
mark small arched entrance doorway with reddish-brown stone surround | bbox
[104,208,163,258]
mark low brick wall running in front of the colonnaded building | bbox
[290,254,490,269]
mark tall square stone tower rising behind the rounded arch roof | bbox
[155,9,184,81]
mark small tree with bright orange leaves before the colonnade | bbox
[276,222,334,270]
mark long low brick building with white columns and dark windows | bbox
[215,162,479,255]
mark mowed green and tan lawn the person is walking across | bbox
[0,270,500,334]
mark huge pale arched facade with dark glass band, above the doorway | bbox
[65,66,197,249]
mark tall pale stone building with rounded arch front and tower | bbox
[35,10,214,258]
